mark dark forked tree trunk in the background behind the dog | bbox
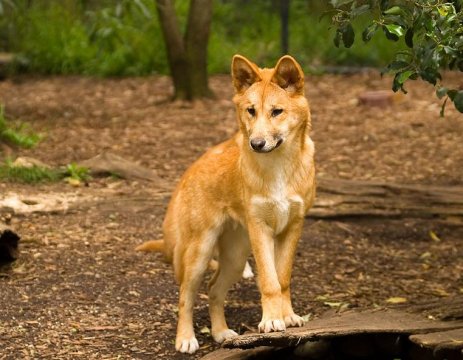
[156,0,212,100]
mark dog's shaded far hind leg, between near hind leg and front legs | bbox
[209,227,251,343]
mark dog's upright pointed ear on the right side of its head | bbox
[272,55,304,95]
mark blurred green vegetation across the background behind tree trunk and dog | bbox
[0,0,404,76]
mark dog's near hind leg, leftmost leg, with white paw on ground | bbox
[174,230,218,354]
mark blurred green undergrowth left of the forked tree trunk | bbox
[4,0,167,76]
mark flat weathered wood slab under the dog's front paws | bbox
[223,310,463,349]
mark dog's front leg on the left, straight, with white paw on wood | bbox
[248,221,286,332]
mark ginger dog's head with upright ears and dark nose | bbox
[232,55,310,153]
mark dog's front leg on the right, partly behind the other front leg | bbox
[275,218,304,327]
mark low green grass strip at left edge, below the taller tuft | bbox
[0,159,62,183]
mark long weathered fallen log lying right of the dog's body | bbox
[309,178,463,221]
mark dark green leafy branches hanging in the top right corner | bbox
[331,0,463,115]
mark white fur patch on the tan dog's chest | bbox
[251,176,304,234]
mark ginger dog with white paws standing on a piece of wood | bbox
[138,55,315,354]
